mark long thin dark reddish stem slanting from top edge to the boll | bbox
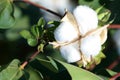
[14,0,62,18]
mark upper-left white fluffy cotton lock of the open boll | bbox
[54,22,78,42]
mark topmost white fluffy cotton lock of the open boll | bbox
[73,6,98,35]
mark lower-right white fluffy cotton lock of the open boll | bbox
[80,35,101,61]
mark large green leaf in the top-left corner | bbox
[0,0,15,29]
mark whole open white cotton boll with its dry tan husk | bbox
[50,5,109,67]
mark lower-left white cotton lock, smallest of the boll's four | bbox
[60,41,81,63]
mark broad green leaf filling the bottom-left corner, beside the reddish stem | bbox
[0,59,23,80]
